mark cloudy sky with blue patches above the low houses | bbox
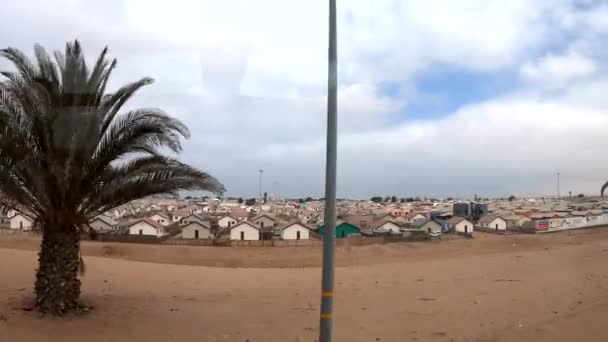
[0,0,608,198]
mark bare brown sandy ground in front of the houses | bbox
[0,229,608,342]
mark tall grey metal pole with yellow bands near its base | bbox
[319,0,338,342]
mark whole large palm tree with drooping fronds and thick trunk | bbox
[0,41,224,315]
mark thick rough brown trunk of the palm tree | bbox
[35,227,80,315]
